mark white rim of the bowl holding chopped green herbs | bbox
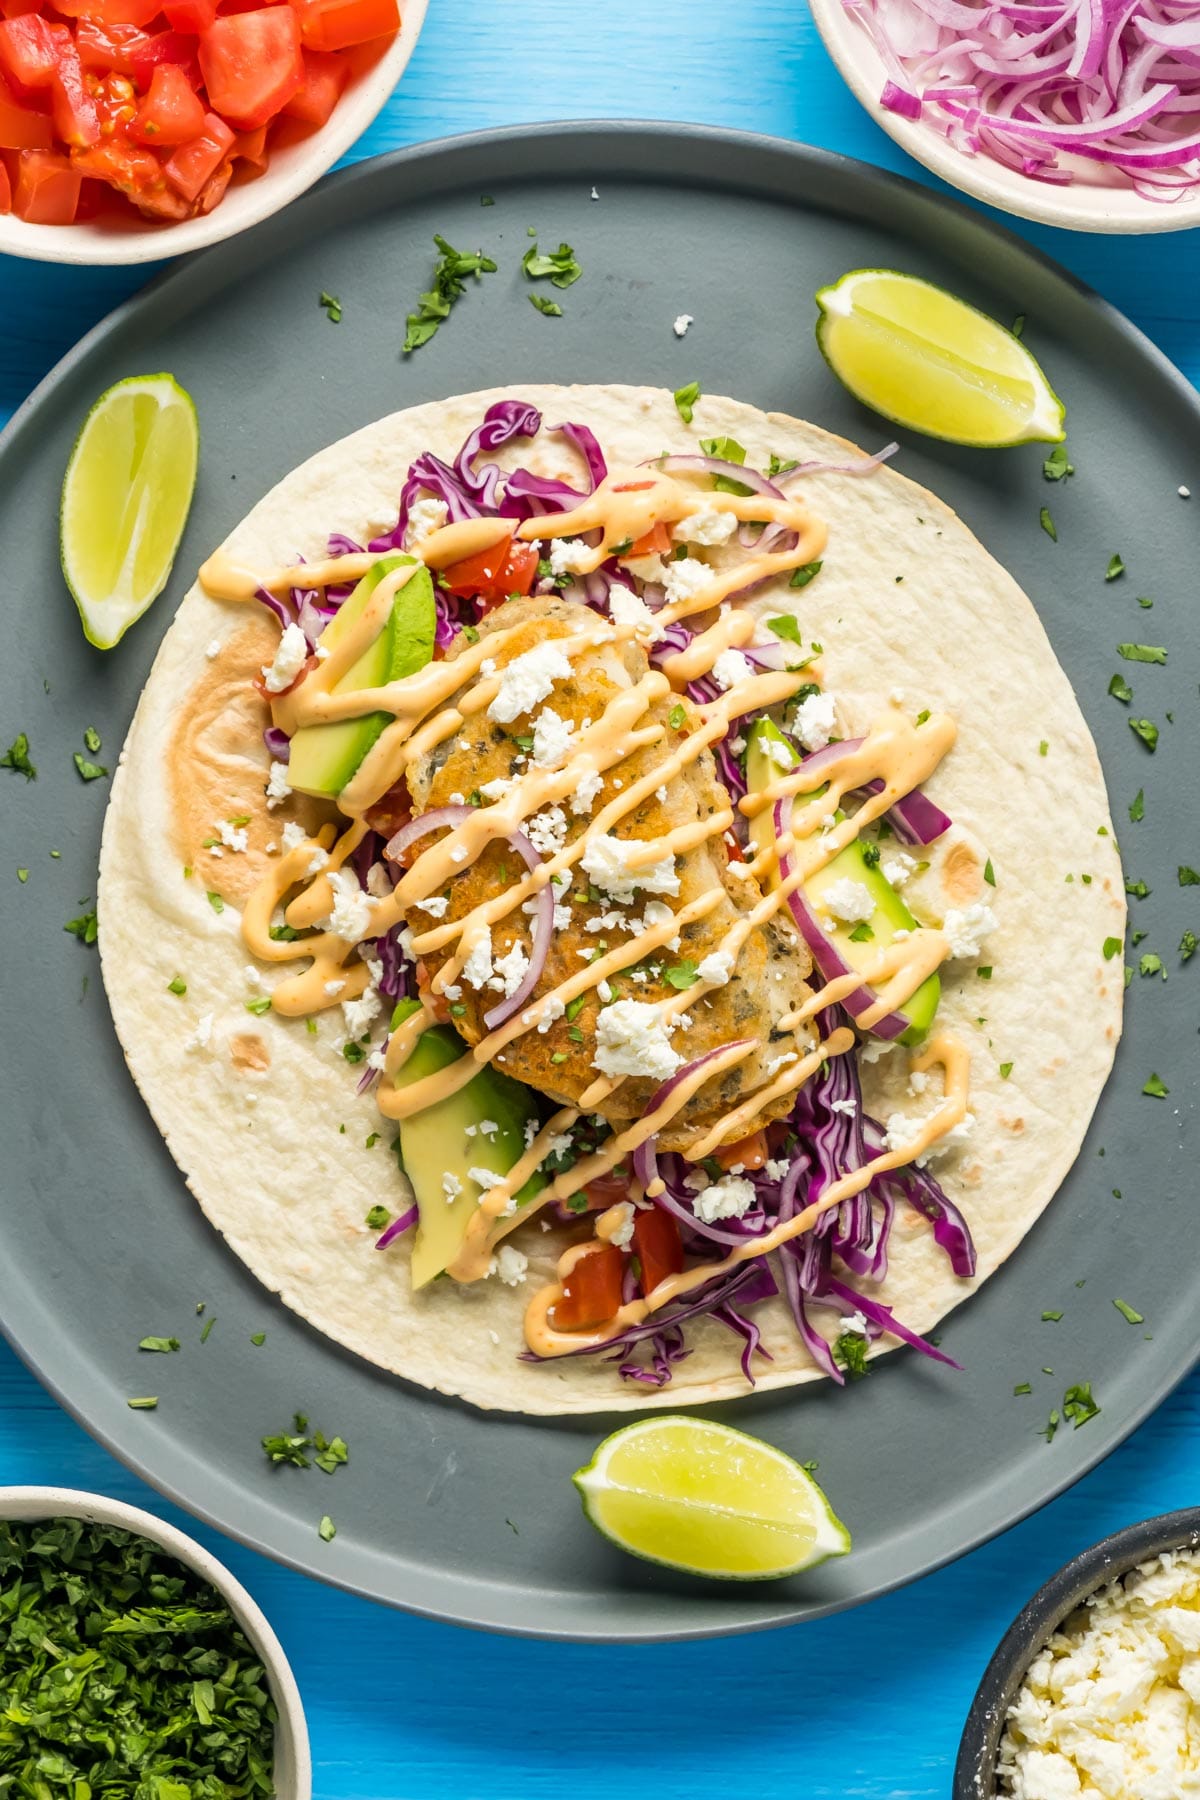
[0,1487,313,1800]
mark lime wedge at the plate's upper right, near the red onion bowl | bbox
[817,268,1065,450]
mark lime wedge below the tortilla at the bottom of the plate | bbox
[572,1417,849,1580]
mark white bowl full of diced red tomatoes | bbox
[0,0,428,263]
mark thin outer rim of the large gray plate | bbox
[0,119,1200,1643]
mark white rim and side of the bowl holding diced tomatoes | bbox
[0,0,428,265]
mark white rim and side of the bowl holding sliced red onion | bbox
[810,0,1200,232]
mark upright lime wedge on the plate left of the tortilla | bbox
[59,374,200,650]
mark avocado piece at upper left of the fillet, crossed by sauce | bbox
[288,556,437,796]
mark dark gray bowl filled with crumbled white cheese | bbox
[954,1507,1200,1800]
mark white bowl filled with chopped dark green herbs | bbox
[0,1487,313,1800]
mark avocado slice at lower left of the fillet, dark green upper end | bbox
[392,1001,545,1289]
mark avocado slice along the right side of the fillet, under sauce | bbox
[747,718,941,1044]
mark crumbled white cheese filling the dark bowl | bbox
[997,1552,1200,1800]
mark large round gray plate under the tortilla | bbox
[0,124,1200,1640]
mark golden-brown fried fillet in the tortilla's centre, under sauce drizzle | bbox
[407,596,813,1150]
